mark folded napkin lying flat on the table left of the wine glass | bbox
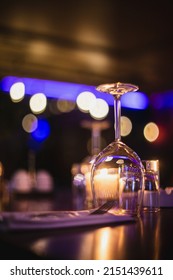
[0,211,135,231]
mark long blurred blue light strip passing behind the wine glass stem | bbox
[1,76,148,110]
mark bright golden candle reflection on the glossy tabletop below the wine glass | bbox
[78,225,127,260]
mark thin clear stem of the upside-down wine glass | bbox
[114,95,121,141]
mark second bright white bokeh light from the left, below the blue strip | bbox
[29,93,47,114]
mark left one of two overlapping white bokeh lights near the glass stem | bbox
[76,91,96,112]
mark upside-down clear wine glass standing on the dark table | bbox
[91,82,144,216]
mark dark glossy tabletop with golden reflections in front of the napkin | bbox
[0,191,173,260]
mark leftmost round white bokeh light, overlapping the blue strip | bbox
[10,82,25,102]
